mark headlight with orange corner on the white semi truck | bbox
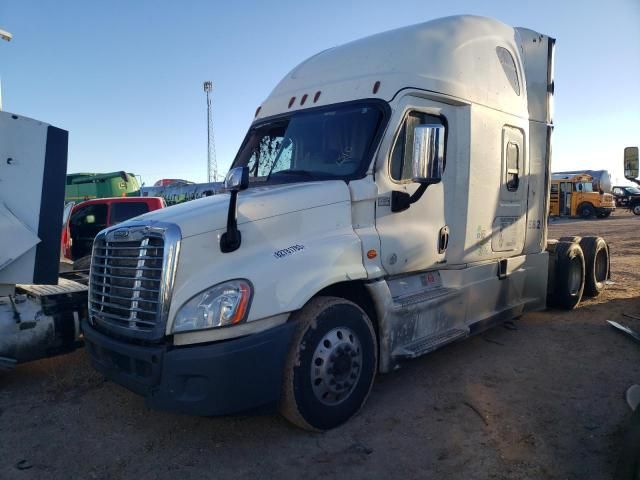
[173,280,251,333]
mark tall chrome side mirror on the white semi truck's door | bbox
[413,124,445,185]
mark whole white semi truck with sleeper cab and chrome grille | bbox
[83,16,608,430]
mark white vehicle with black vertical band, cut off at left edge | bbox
[0,112,87,370]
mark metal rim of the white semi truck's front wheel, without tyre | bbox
[311,328,362,405]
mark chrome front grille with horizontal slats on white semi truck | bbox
[89,225,179,339]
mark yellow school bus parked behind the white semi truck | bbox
[549,173,616,218]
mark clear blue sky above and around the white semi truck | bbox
[0,0,640,184]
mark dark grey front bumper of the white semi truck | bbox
[82,322,294,416]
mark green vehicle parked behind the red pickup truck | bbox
[64,171,140,202]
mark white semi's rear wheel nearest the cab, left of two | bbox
[549,241,585,310]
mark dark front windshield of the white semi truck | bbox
[232,103,383,183]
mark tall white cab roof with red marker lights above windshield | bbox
[256,15,528,118]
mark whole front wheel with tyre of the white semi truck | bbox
[280,297,378,430]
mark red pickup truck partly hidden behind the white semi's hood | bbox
[62,197,166,270]
